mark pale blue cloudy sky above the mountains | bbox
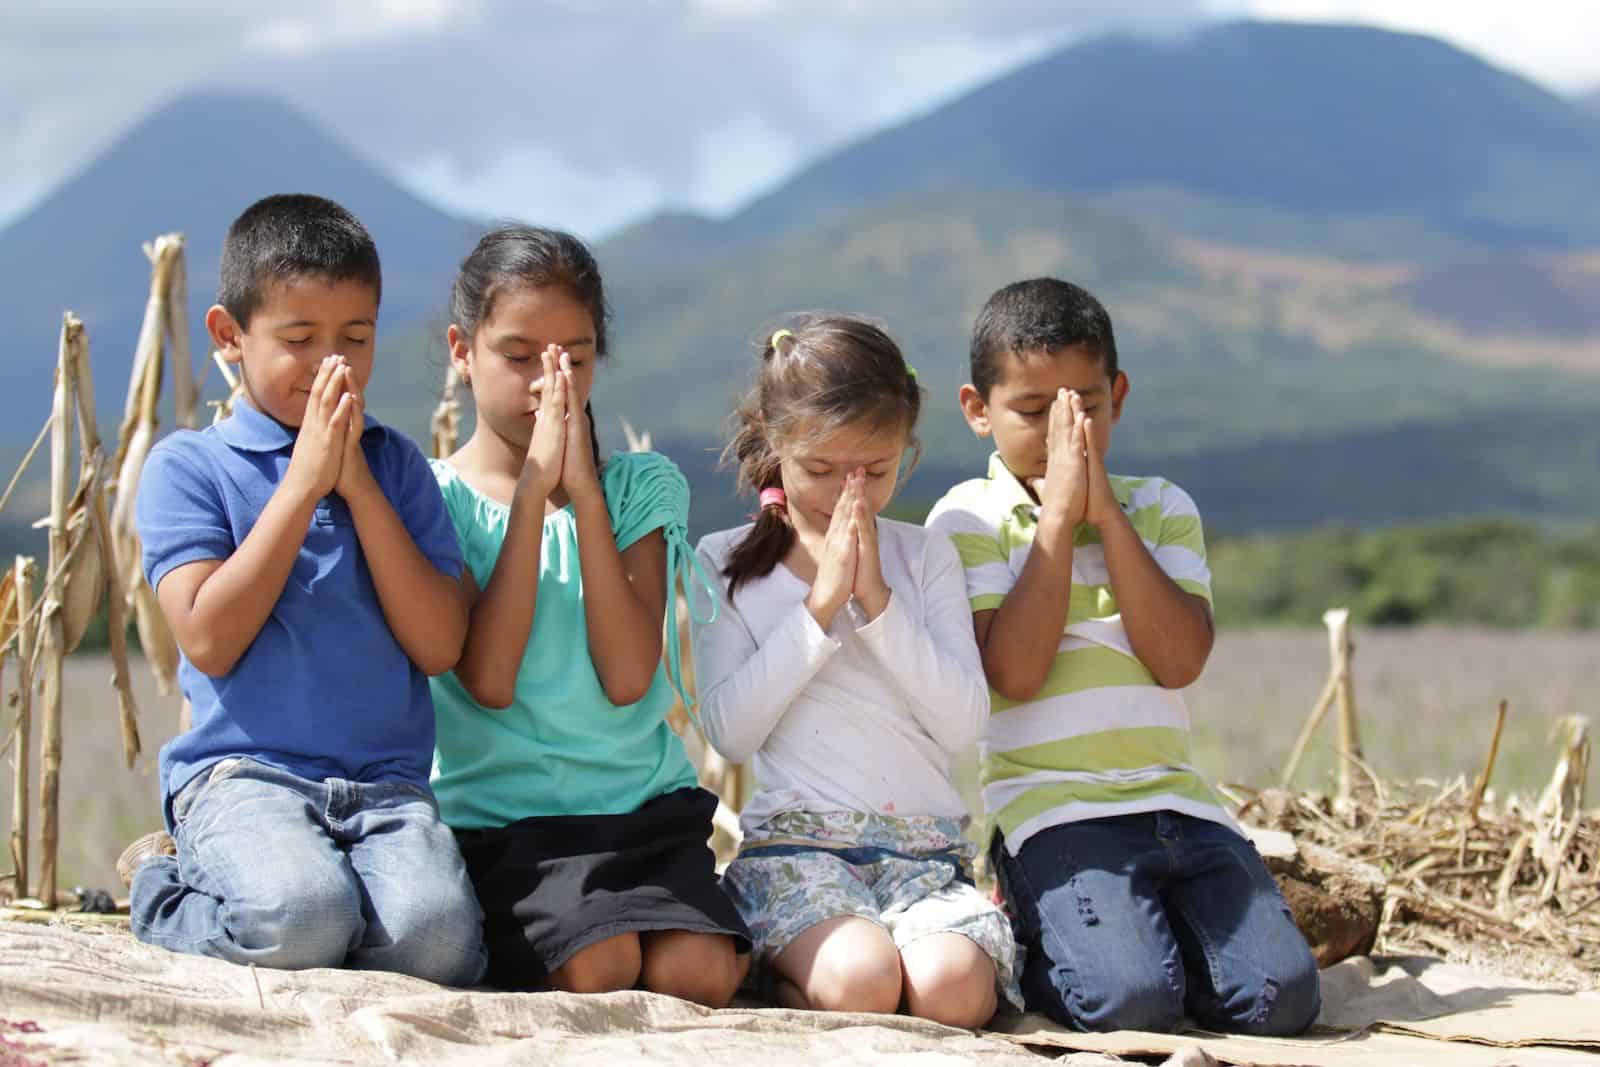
[0,0,1600,237]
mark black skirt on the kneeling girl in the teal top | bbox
[456,787,750,990]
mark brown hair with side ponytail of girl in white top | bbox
[722,314,922,598]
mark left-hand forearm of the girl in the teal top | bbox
[456,486,547,709]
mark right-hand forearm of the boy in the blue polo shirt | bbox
[346,482,467,675]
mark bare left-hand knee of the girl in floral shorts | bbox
[774,917,901,1014]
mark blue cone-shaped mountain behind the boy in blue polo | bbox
[0,91,475,435]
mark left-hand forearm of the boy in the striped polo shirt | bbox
[978,512,1075,701]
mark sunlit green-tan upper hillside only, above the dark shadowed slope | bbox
[576,190,1600,453]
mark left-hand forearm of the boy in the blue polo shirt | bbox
[168,482,317,678]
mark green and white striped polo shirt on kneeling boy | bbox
[928,453,1237,853]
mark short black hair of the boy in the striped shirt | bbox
[971,278,1117,400]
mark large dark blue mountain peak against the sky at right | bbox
[733,22,1600,248]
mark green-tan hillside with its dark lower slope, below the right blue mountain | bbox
[395,182,1600,531]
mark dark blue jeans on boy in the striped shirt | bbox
[994,811,1322,1035]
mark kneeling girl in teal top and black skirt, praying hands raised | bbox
[432,226,749,1006]
